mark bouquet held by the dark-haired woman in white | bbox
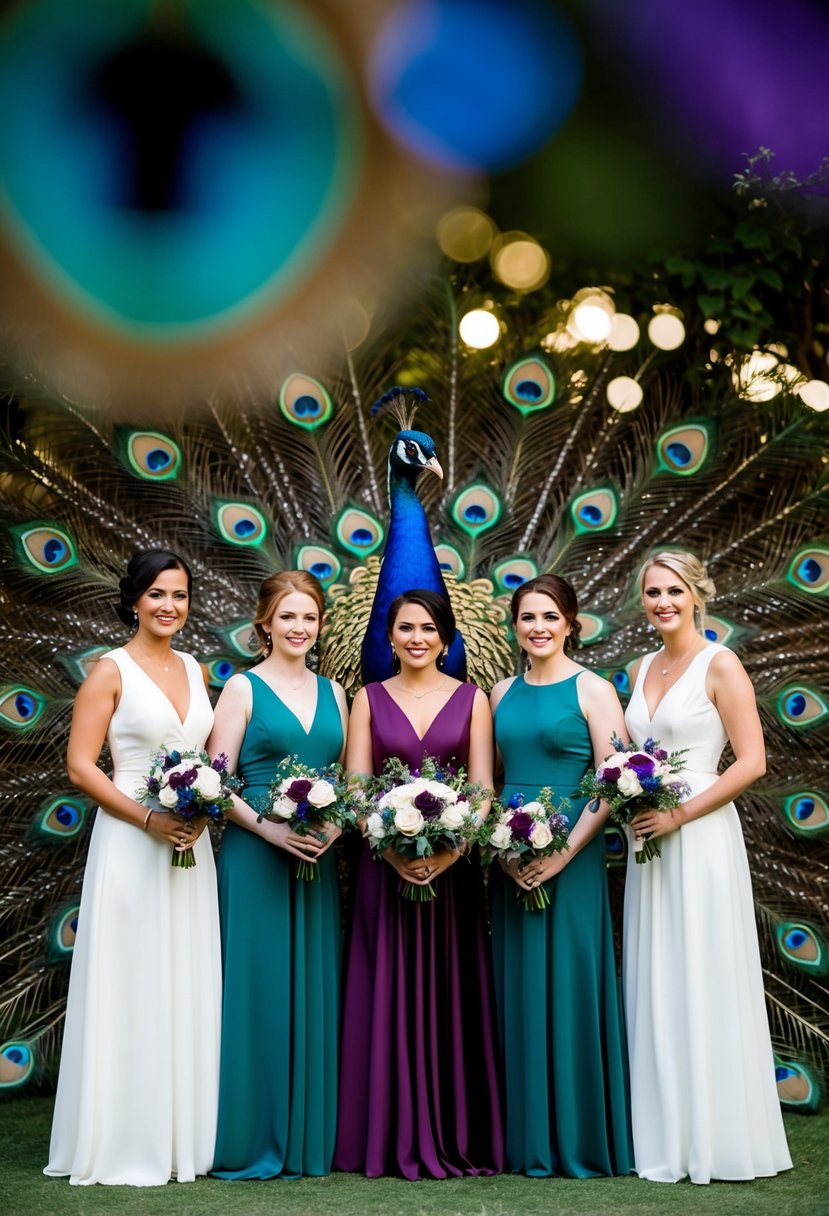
[135,747,237,869]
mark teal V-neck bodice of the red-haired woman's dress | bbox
[237,671,343,799]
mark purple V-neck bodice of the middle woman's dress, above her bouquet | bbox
[366,683,478,772]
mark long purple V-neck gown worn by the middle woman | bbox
[334,683,503,1180]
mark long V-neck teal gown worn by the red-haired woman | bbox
[212,672,343,1178]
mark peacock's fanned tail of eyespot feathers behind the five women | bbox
[0,271,829,1109]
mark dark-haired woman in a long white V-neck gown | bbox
[44,550,221,1187]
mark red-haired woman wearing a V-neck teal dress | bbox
[208,570,348,1178]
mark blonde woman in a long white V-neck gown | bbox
[624,553,791,1182]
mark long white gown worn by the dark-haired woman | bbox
[44,649,221,1187]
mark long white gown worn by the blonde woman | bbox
[624,644,791,1182]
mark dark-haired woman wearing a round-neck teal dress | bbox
[492,574,633,1178]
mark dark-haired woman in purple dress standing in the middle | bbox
[334,590,503,1180]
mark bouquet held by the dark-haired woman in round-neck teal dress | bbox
[478,786,570,912]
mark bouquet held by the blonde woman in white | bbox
[579,734,690,865]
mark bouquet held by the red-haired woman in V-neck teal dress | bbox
[256,756,356,883]
